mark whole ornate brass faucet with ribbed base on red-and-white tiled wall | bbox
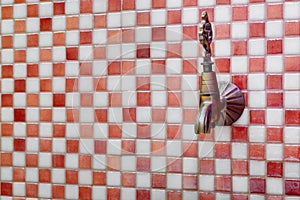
[195,11,245,134]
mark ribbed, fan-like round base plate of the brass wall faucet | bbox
[218,82,245,126]
